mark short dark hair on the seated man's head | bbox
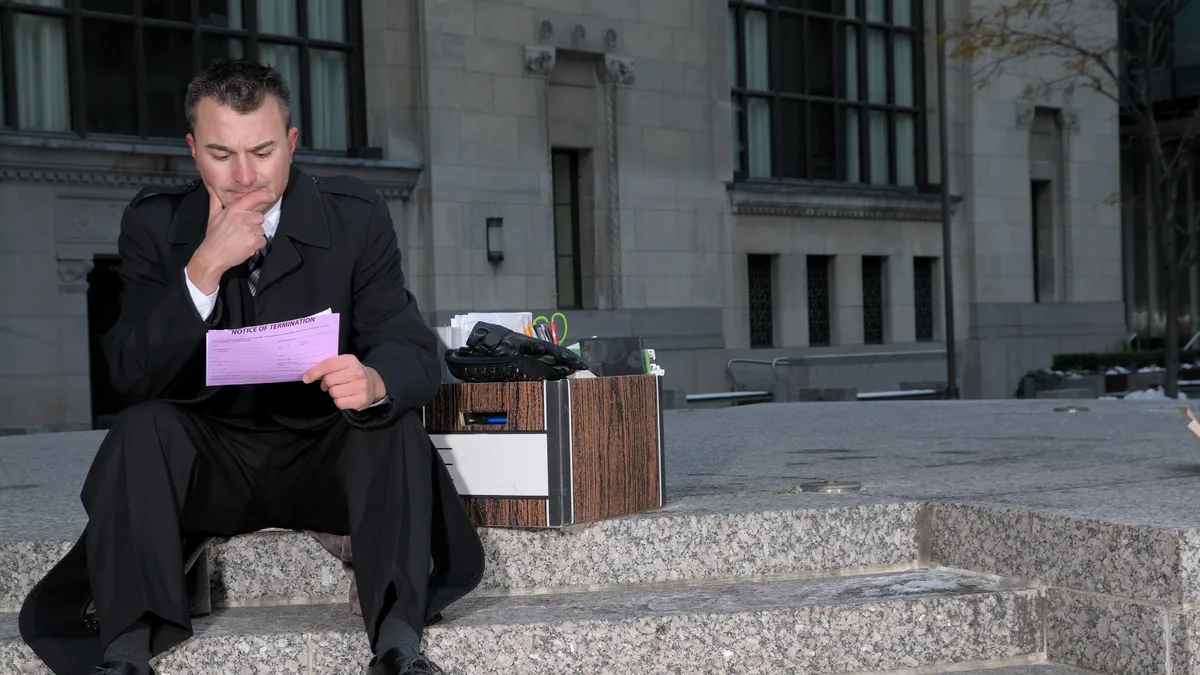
[184,59,292,131]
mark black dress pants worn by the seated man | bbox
[82,402,436,655]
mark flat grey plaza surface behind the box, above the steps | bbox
[0,400,1200,540]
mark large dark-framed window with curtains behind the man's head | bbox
[0,0,366,153]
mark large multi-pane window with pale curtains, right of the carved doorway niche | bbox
[727,0,924,186]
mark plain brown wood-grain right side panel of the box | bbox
[568,375,662,522]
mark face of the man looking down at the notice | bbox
[187,95,299,213]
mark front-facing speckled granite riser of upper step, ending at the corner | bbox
[0,495,919,611]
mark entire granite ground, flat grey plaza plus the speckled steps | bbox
[0,400,1200,675]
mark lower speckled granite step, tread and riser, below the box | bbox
[0,569,1041,675]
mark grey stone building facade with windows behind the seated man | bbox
[0,0,1126,428]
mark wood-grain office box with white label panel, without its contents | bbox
[422,375,665,528]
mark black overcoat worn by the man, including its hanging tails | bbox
[20,167,484,675]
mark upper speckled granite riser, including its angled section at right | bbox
[14,495,1200,610]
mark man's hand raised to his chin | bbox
[187,185,277,294]
